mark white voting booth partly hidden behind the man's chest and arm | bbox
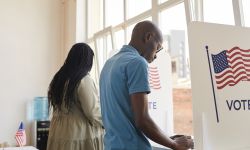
[148,50,173,147]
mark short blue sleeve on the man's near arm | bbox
[126,57,150,95]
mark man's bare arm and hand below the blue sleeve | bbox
[130,93,192,150]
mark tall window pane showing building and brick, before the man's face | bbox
[159,3,193,135]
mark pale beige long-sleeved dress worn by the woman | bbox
[47,75,104,150]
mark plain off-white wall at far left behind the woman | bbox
[0,0,65,145]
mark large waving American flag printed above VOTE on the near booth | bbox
[212,47,250,89]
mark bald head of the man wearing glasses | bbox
[129,21,163,63]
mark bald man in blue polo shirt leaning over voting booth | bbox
[100,21,193,150]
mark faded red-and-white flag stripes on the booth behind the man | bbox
[149,66,161,90]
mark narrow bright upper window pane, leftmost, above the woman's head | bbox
[87,0,103,38]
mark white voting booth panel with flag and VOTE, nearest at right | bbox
[188,22,250,150]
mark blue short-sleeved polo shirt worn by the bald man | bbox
[100,45,152,150]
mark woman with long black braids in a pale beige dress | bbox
[47,43,104,150]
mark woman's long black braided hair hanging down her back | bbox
[48,43,94,111]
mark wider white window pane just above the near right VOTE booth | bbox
[203,0,235,25]
